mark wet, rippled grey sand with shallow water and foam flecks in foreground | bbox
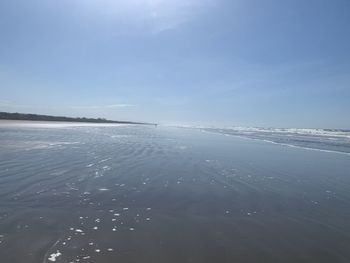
[0,122,350,263]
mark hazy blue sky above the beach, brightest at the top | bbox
[0,0,350,129]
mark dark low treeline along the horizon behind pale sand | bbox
[0,112,156,125]
